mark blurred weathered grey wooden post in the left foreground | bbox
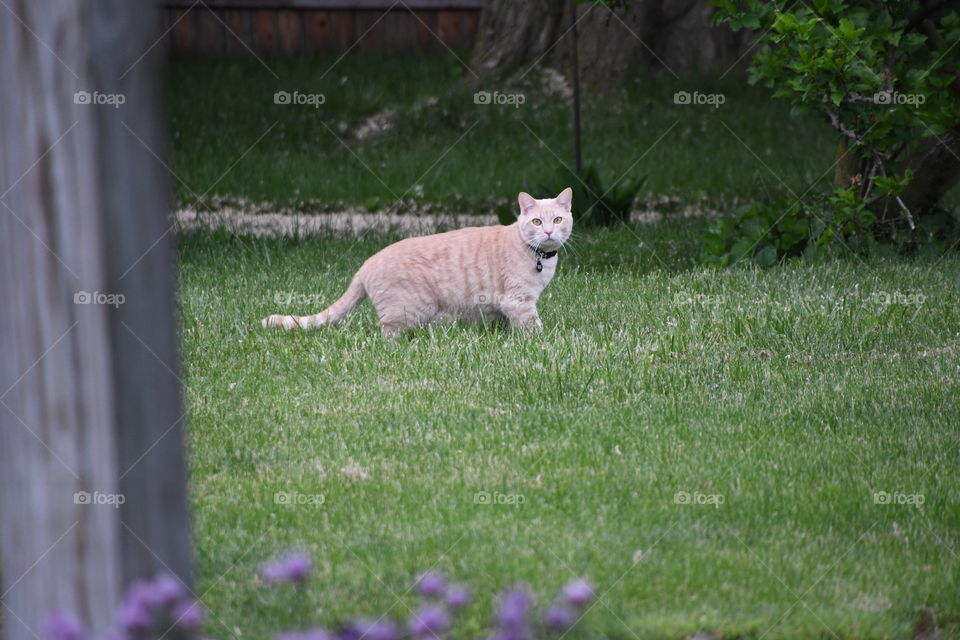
[0,5,191,640]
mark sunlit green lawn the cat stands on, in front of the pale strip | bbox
[181,221,960,639]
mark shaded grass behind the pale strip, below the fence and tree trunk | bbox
[170,55,836,210]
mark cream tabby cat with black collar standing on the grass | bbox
[261,188,573,339]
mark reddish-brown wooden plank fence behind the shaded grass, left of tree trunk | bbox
[162,0,482,57]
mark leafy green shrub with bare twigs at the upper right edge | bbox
[701,0,960,264]
